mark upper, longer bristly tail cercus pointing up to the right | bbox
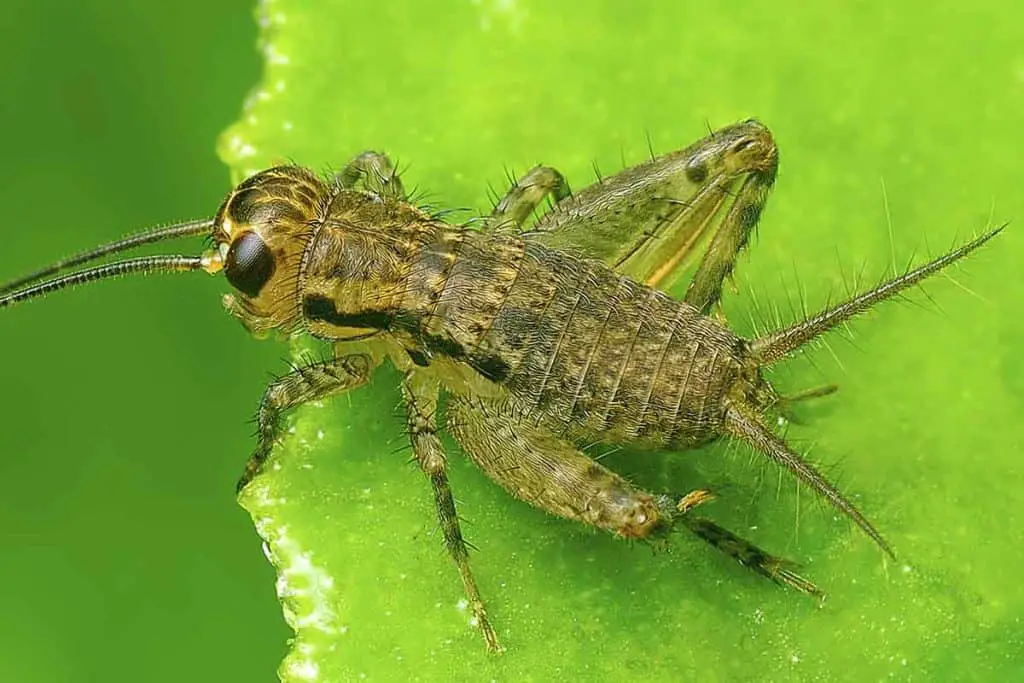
[751,223,1007,368]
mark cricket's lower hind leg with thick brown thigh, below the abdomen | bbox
[447,397,820,595]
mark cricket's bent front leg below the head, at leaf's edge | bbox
[237,354,373,493]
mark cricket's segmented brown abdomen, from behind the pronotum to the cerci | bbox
[411,227,741,445]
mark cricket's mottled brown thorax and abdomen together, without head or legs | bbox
[300,195,741,445]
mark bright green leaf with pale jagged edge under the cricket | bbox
[220,0,1024,681]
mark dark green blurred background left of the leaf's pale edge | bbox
[0,0,289,683]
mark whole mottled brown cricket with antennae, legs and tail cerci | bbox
[0,120,1005,651]
